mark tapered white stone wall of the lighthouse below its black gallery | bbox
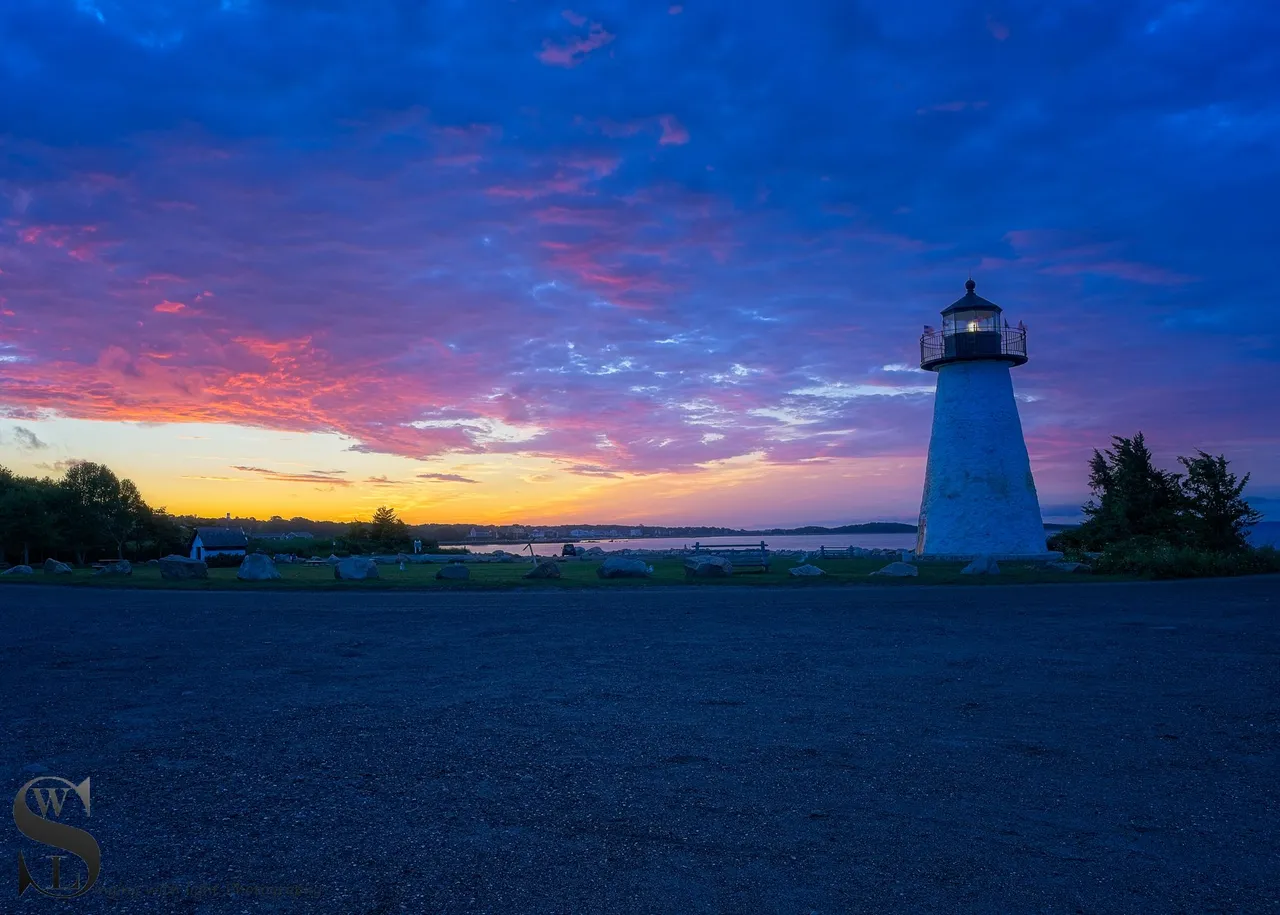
[916,362,1046,555]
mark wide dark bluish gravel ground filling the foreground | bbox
[0,577,1280,915]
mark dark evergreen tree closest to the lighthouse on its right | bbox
[1079,433,1185,549]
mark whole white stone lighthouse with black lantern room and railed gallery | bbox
[915,279,1057,559]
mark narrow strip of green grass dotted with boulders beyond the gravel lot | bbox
[0,558,1135,591]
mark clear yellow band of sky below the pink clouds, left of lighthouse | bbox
[0,418,924,527]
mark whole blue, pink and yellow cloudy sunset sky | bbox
[0,0,1280,526]
